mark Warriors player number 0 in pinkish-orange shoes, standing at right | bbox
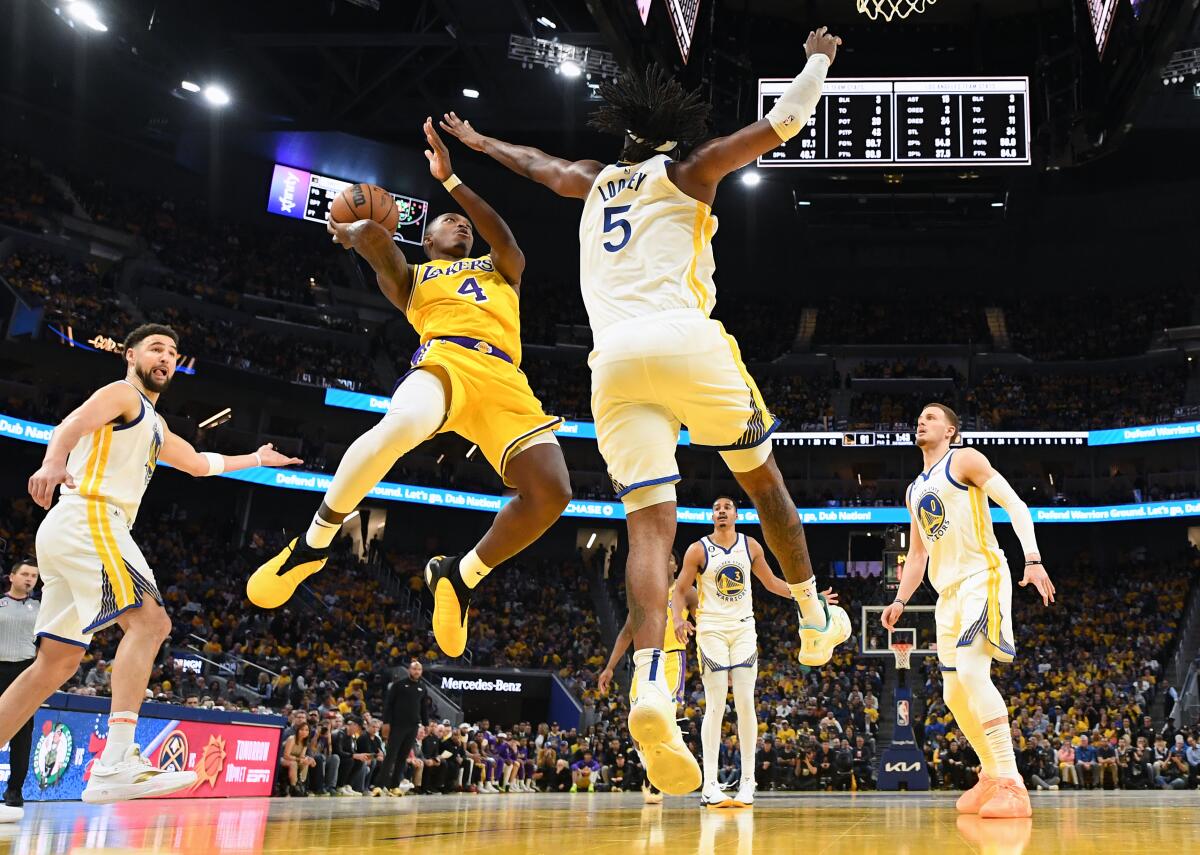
[881,403,1055,818]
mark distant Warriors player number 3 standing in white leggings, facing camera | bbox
[671,496,838,807]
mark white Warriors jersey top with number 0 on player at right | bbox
[905,450,1008,593]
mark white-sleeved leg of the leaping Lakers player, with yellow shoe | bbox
[246,369,449,609]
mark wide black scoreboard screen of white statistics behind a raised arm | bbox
[758,77,1032,167]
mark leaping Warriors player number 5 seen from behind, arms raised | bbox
[442,28,850,794]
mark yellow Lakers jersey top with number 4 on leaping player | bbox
[404,250,521,365]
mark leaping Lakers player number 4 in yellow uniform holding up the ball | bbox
[246,119,571,657]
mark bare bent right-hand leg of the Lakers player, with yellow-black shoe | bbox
[425,432,571,657]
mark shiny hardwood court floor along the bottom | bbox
[0,790,1200,855]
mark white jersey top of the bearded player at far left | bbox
[62,381,166,526]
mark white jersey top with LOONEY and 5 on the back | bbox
[580,155,716,336]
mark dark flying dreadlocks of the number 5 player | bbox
[588,64,713,160]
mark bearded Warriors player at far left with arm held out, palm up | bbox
[0,324,300,821]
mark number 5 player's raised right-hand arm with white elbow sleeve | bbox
[671,26,841,204]
